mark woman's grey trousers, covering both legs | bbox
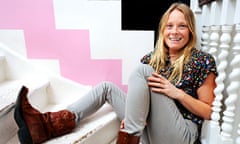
[67,64,198,144]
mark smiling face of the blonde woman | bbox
[163,9,189,53]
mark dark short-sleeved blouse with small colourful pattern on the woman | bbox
[141,48,218,128]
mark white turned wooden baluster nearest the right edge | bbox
[226,24,240,144]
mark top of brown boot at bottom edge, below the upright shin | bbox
[117,131,140,144]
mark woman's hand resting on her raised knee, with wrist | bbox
[148,72,185,99]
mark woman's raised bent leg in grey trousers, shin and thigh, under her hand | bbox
[117,64,197,144]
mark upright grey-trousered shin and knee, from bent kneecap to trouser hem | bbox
[123,64,154,136]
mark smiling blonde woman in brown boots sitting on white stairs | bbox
[14,3,217,144]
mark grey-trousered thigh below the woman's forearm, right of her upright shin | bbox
[147,92,198,144]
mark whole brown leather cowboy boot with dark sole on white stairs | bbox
[14,86,75,144]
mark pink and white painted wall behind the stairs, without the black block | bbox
[0,0,154,90]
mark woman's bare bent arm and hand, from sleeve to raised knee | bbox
[148,73,216,119]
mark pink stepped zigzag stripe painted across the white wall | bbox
[0,0,126,90]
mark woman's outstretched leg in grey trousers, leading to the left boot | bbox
[67,82,126,124]
